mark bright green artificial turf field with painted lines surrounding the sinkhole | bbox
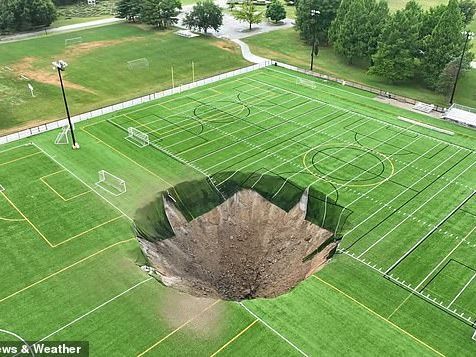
[0,67,476,356]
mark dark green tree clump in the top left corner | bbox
[0,0,56,32]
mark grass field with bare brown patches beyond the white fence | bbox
[0,24,247,134]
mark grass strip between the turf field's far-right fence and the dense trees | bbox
[244,29,476,107]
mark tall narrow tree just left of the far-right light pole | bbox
[420,0,464,89]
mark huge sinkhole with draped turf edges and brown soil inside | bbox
[135,173,349,300]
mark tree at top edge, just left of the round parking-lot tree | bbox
[140,0,182,29]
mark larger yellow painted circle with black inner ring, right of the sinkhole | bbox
[303,144,395,187]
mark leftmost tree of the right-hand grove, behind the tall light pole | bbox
[296,0,340,43]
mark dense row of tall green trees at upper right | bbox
[296,0,476,92]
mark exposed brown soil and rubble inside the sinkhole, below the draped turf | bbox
[138,189,337,300]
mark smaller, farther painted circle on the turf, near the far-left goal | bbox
[193,100,250,124]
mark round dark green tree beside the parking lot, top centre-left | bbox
[183,0,223,33]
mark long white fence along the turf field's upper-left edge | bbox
[0,61,271,145]
